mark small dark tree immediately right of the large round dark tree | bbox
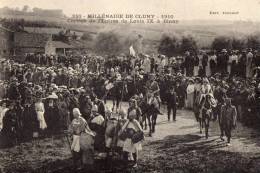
[180,36,198,53]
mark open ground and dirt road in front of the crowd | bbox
[0,104,260,173]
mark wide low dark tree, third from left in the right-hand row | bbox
[211,36,232,52]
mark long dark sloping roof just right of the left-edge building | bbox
[14,32,50,48]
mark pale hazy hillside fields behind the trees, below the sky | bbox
[0,11,260,53]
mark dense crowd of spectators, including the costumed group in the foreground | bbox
[0,49,260,170]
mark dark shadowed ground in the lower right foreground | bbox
[139,135,260,173]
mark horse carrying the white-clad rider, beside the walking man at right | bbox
[196,94,216,139]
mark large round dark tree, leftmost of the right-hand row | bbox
[158,35,179,57]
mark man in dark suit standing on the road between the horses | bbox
[167,86,177,121]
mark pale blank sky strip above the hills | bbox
[0,0,260,21]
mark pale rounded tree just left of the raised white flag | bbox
[95,32,122,55]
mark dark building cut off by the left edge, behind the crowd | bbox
[0,26,14,58]
